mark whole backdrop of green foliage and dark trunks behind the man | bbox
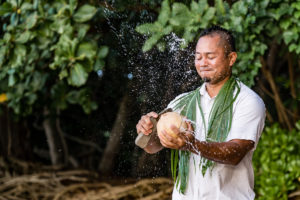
[0,0,300,199]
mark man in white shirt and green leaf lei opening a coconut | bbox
[136,26,265,200]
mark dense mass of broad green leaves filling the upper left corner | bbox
[0,0,108,115]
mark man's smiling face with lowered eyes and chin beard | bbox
[195,34,236,84]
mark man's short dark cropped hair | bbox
[199,25,236,54]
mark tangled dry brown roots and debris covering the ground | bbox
[0,170,173,200]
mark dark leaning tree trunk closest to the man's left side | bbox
[99,95,129,175]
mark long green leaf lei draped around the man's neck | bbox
[171,77,240,193]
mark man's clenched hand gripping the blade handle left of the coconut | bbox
[136,112,158,135]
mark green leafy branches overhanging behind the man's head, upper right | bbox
[136,0,300,86]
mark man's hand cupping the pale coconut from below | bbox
[159,122,195,150]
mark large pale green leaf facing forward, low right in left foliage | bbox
[68,63,88,86]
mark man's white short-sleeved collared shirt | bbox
[168,82,265,200]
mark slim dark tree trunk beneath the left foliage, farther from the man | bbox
[43,107,68,165]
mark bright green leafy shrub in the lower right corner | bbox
[253,121,300,200]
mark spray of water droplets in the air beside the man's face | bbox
[99,4,199,112]
